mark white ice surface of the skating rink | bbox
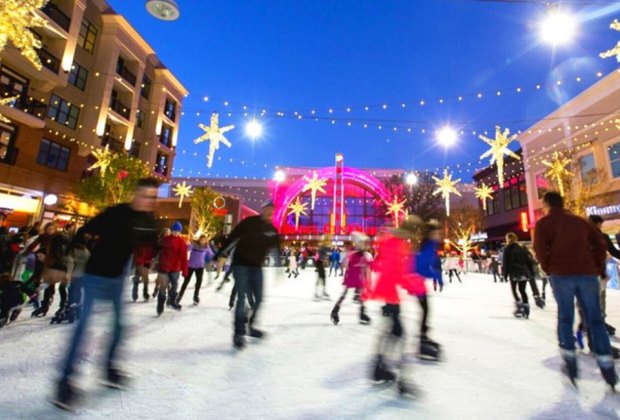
[0,269,620,420]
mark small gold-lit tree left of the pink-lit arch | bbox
[190,187,224,238]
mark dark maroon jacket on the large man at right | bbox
[534,209,606,276]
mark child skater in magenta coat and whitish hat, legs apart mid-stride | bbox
[330,232,372,325]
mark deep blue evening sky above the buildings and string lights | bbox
[109,0,620,177]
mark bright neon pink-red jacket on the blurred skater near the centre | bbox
[364,233,426,305]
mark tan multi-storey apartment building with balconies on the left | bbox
[0,0,188,230]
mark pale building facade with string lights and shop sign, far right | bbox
[519,70,620,233]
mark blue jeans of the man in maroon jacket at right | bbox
[550,275,611,356]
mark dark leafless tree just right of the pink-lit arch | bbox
[385,172,444,221]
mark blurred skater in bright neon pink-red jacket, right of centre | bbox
[363,216,425,395]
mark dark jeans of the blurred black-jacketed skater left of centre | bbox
[233,265,263,335]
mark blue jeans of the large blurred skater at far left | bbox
[61,274,125,382]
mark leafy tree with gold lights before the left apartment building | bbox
[78,152,149,210]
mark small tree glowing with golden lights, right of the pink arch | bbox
[447,203,484,257]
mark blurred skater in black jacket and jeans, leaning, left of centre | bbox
[216,201,280,350]
